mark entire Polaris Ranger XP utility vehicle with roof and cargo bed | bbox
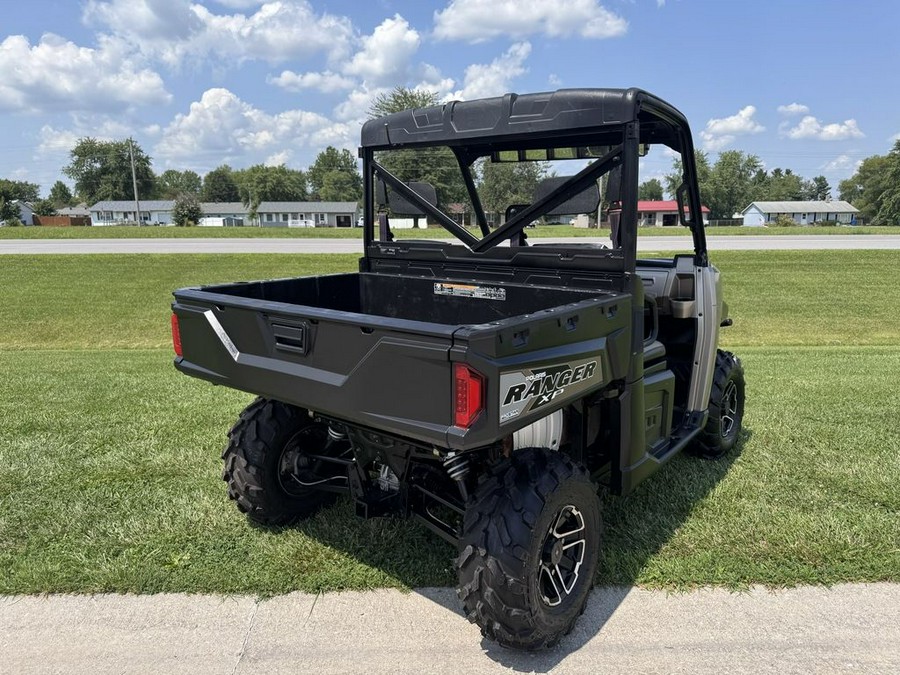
[172,89,744,649]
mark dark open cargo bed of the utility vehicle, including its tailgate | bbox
[173,273,627,448]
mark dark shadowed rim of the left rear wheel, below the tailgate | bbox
[278,424,348,497]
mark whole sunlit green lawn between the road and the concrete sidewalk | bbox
[0,251,900,594]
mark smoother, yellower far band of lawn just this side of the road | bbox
[0,251,900,349]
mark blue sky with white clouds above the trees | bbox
[0,0,900,197]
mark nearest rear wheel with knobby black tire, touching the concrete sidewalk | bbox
[457,448,600,650]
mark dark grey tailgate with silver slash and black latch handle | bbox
[172,288,457,445]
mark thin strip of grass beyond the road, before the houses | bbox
[0,225,900,239]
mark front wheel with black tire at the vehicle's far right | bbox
[694,349,745,459]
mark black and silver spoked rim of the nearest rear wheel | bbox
[538,505,587,607]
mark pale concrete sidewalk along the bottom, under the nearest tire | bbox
[0,584,900,675]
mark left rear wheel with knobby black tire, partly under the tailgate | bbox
[222,398,346,526]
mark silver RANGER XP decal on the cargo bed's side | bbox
[500,361,600,423]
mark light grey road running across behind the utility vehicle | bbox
[0,234,900,254]
